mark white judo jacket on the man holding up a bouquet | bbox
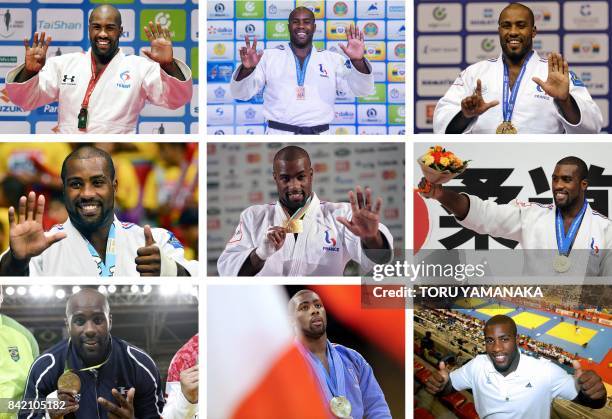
[457,194,612,277]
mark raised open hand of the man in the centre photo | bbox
[337,186,382,241]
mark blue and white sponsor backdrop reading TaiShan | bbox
[0,0,199,134]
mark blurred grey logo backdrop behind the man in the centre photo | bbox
[206,143,405,275]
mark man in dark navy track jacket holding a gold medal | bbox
[19,288,164,419]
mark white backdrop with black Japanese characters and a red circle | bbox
[414,142,612,250]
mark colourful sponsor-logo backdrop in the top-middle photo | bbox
[206,0,406,135]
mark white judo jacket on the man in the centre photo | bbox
[217,193,393,276]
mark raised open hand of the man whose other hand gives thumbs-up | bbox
[8,192,66,261]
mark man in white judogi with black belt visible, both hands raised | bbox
[230,7,374,135]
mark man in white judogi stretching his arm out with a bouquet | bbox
[419,156,612,276]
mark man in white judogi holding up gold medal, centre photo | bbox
[217,146,393,276]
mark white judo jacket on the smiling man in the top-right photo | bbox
[433,51,603,134]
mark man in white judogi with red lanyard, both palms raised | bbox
[6,5,193,134]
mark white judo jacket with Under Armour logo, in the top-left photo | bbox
[6,49,193,134]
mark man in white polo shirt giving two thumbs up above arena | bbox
[426,315,606,419]
